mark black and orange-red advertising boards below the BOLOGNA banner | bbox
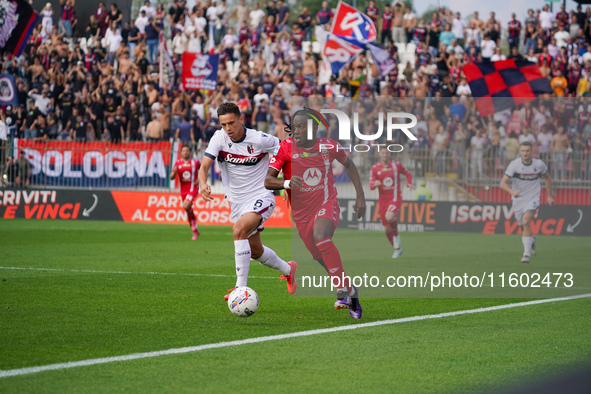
[0,189,291,227]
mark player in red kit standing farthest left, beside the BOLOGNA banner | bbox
[170,145,201,241]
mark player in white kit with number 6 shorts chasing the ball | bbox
[199,102,298,299]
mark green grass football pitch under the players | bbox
[0,220,591,393]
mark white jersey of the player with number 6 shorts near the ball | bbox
[205,127,280,203]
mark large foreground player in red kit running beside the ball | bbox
[265,108,365,319]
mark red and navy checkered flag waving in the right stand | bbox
[464,59,554,116]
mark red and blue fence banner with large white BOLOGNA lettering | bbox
[14,139,172,187]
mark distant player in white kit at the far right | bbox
[501,141,554,263]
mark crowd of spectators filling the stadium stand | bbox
[0,0,591,180]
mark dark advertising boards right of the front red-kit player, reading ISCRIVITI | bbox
[339,199,591,236]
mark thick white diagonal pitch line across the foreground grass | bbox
[0,294,591,378]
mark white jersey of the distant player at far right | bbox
[505,157,548,205]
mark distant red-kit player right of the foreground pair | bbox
[369,149,412,259]
